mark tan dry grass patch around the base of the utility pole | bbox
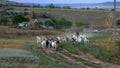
[89,32,120,64]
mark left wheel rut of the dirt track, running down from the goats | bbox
[44,49,100,68]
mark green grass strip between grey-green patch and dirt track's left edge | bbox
[24,44,83,68]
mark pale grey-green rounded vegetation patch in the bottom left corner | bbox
[0,48,39,68]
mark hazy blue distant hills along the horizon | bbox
[0,0,120,8]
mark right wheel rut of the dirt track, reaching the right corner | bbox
[61,49,120,68]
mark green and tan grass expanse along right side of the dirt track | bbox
[59,34,120,64]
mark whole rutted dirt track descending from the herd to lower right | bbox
[33,43,120,68]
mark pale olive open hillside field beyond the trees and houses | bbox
[12,7,120,25]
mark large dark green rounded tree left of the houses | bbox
[12,14,29,26]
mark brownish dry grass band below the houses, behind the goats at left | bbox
[0,26,60,38]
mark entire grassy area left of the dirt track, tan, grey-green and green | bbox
[0,38,83,68]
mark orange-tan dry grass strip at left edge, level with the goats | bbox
[0,39,35,48]
